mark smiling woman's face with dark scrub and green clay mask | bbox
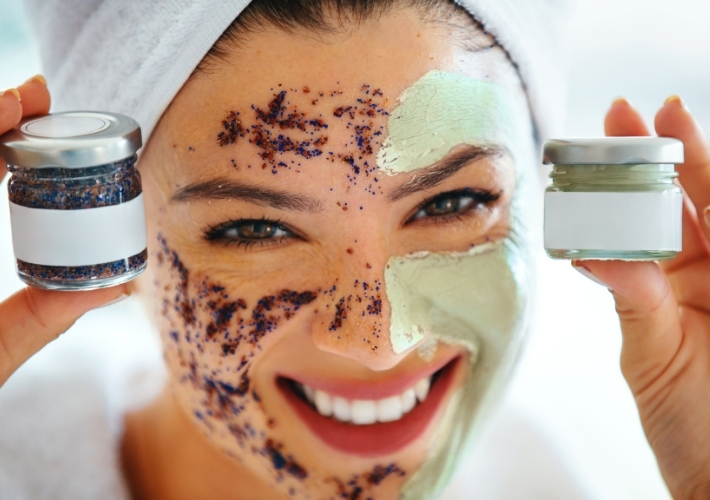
[141,7,532,498]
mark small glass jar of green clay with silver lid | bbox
[543,137,683,260]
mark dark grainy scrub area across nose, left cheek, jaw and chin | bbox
[148,238,420,498]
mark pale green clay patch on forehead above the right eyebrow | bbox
[377,71,518,175]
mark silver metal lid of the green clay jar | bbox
[542,137,684,165]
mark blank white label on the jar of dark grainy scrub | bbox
[10,194,147,266]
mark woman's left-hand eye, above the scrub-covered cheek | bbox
[204,219,294,247]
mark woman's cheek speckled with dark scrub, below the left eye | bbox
[155,234,317,406]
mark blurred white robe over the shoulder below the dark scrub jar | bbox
[0,360,129,500]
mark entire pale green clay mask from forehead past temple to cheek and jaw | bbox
[377,71,535,500]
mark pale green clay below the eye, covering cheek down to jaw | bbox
[385,241,528,498]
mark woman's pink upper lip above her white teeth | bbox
[279,353,459,400]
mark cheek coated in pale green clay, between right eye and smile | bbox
[385,242,520,354]
